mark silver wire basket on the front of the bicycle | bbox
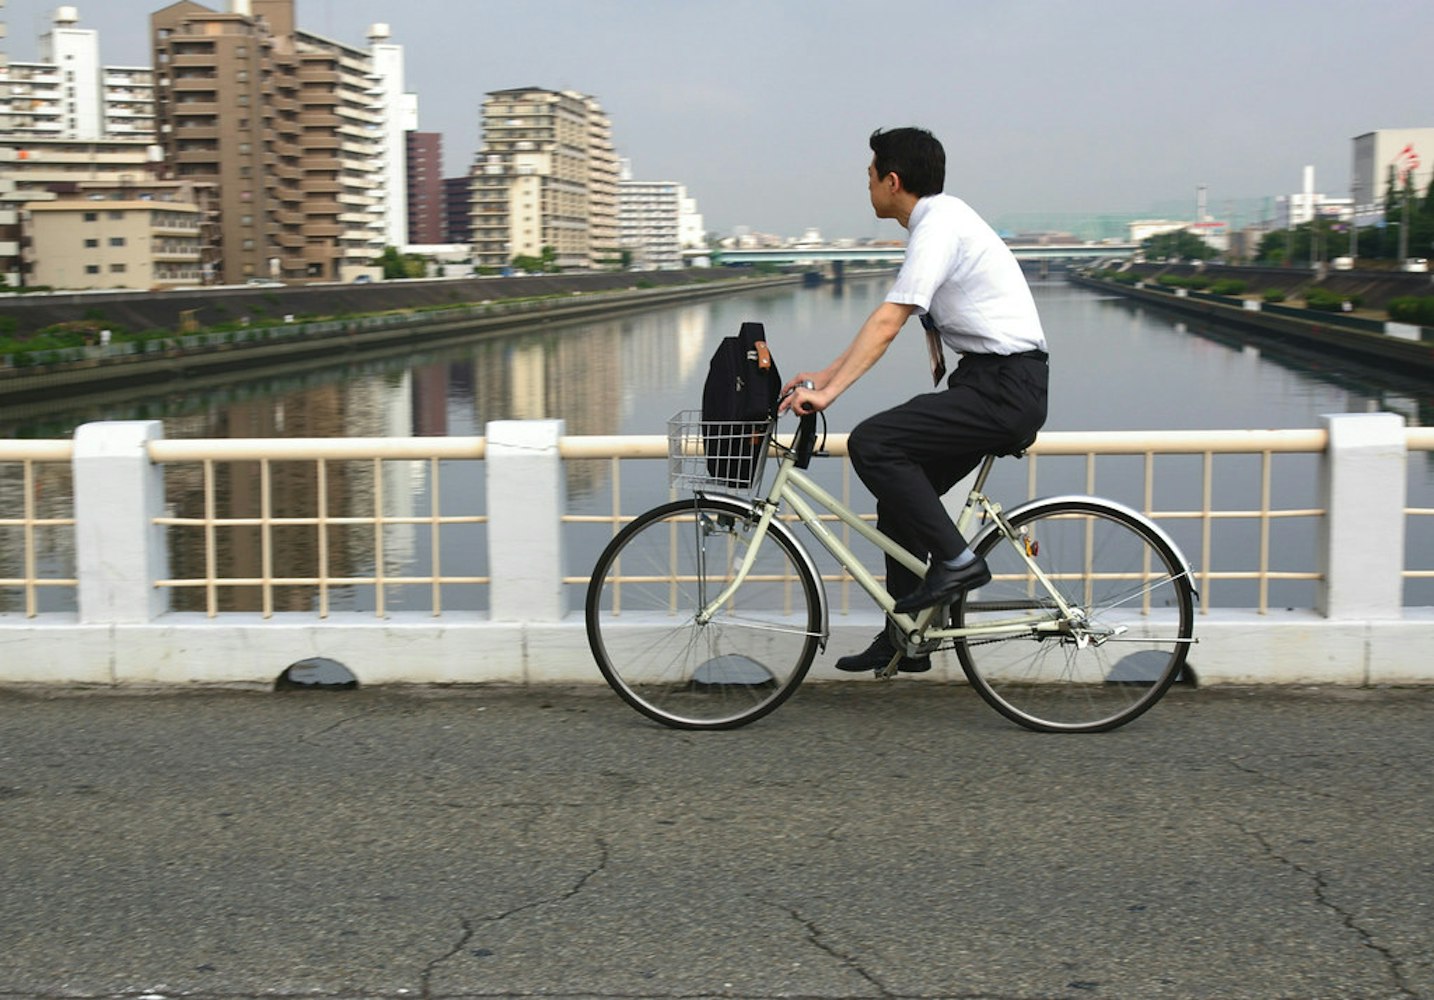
[667,410,773,492]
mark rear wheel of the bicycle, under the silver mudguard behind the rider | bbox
[951,499,1195,732]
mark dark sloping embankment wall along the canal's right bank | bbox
[1067,265,1434,374]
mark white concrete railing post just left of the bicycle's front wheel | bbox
[485,420,568,621]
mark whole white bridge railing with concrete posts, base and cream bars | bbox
[0,413,1434,684]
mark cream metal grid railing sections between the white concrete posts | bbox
[0,428,1434,617]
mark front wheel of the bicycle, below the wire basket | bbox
[587,496,822,729]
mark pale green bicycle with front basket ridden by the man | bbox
[585,412,1196,732]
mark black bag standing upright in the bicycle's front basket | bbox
[703,323,782,488]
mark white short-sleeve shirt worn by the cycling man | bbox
[886,194,1045,354]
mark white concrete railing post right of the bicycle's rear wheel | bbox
[1315,413,1408,618]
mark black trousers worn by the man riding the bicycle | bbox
[847,352,1050,597]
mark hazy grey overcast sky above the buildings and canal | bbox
[3,0,1434,238]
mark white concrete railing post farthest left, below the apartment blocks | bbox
[73,420,169,624]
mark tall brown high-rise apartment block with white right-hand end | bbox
[151,0,413,283]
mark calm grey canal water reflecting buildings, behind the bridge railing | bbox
[0,275,1434,610]
